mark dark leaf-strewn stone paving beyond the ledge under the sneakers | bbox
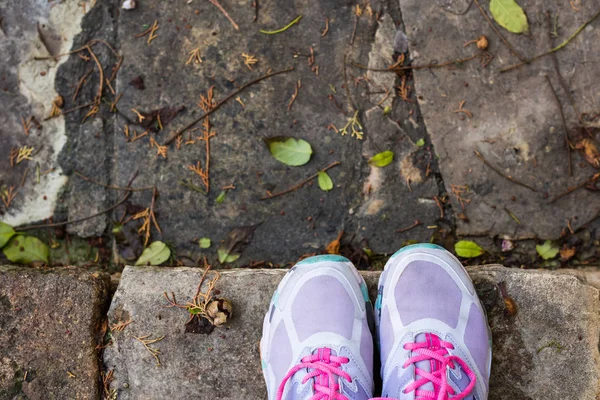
[0,0,600,265]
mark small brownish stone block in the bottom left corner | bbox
[0,267,110,400]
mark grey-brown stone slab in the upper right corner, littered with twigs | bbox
[400,0,600,239]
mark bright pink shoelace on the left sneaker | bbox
[277,348,352,400]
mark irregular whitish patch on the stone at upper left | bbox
[3,0,93,226]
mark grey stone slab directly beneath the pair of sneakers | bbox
[104,266,600,400]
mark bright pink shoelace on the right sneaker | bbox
[403,334,476,400]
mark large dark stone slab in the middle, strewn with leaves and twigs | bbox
[106,0,439,265]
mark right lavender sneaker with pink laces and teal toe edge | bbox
[375,244,492,400]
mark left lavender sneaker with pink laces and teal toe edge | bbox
[260,255,374,400]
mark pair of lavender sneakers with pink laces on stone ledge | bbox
[260,244,492,400]
